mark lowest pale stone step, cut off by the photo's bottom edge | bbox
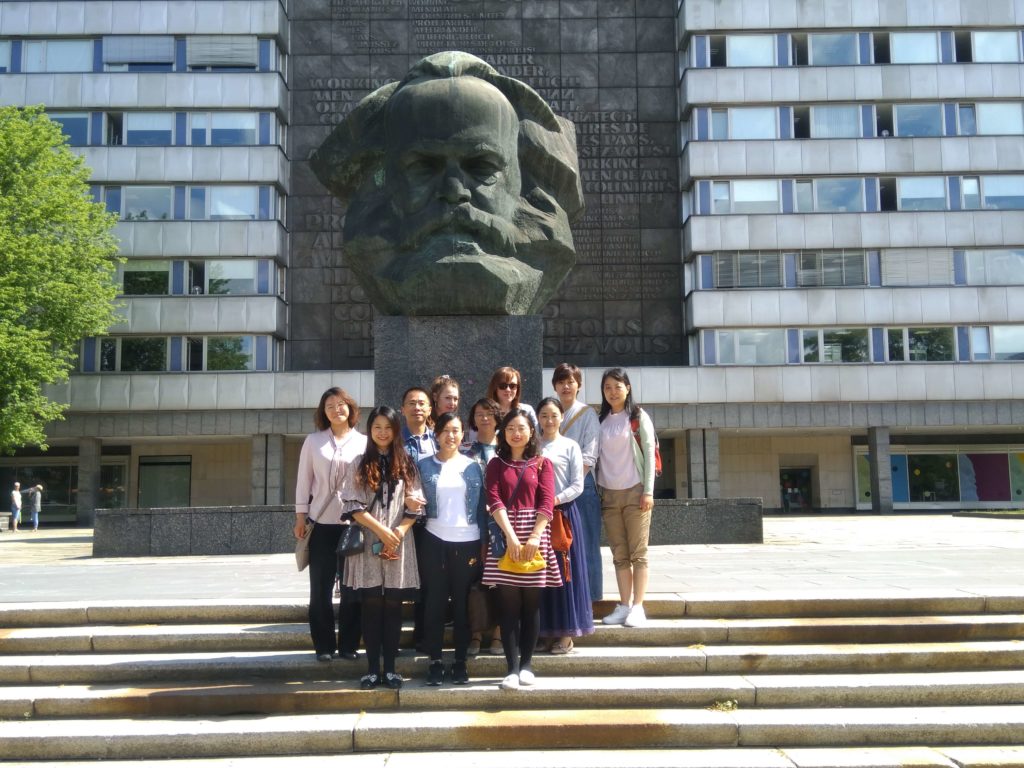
[0,745,1024,768]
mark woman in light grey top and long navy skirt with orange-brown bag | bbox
[537,397,594,654]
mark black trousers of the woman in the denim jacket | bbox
[416,530,483,662]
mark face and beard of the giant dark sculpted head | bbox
[337,77,561,314]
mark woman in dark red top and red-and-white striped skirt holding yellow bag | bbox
[483,409,562,690]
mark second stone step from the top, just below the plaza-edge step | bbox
[0,613,1024,654]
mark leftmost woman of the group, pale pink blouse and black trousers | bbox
[295,387,367,662]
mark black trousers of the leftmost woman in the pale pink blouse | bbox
[309,523,360,655]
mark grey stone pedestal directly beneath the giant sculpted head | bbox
[374,315,546,418]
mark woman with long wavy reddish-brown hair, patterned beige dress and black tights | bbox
[343,406,423,690]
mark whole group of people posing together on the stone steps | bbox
[295,364,654,689]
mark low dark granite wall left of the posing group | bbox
[92,506,295,557]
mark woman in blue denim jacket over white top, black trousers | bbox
[417,413,486,685]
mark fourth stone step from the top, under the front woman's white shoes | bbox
[0,668,1024,719]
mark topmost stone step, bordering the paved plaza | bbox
[0,588,1024,628]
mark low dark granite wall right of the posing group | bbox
[650,499,764,545]
